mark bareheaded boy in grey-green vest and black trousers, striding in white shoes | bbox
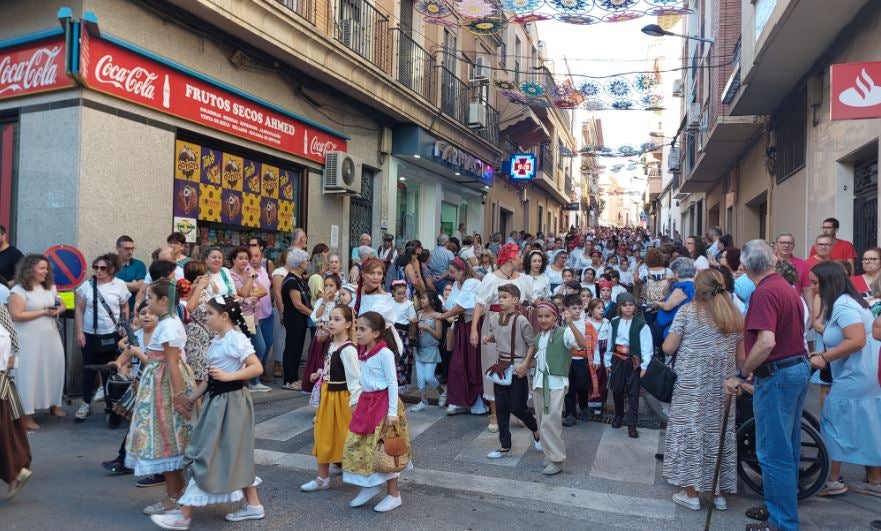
[483,284,541,459]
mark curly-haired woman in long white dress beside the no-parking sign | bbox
[9,254,66,430]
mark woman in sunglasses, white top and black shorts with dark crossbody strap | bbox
[74,254,131,422]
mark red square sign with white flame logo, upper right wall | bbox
[829,61,881,120]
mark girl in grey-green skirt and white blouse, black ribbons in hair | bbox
[150,295,265,529]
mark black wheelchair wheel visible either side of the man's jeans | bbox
[736,393,830,500]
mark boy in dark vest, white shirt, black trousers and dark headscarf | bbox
[606,293,652,439]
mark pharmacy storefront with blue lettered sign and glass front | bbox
[391,127,495,245]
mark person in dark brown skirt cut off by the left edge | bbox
[0,304,31,500]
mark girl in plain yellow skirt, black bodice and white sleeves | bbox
[300,306,361,492]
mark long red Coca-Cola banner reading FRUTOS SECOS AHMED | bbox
[81,31,347,164]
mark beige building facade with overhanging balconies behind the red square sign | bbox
[678,0,881,255]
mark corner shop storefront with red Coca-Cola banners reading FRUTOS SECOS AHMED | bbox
[0,11,364,259]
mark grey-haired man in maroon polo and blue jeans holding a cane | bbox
[725,240,811,529]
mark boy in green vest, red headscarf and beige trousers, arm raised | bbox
[527,302,585,476]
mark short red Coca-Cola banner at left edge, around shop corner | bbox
[0,35,73,99]
